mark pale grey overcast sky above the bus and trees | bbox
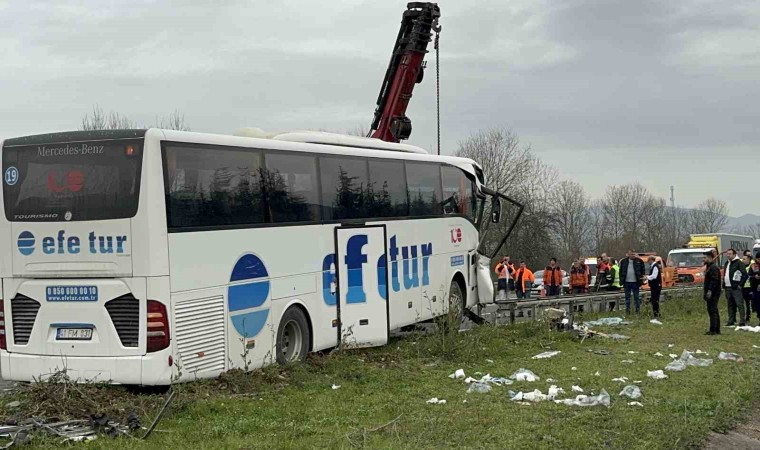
[0,0,760,216]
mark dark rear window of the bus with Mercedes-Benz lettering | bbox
[3,139,142,222]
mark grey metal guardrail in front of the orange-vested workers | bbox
[478,285,702,325]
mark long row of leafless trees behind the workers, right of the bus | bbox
[456,129,760,268]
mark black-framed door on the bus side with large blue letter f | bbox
[335,225,389,348]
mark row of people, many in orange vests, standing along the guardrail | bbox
[495,250,664,318]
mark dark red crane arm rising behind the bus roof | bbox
[370,2,441,142]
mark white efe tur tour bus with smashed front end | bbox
[0,129,521,385]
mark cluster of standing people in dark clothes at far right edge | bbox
[704,248,760,335]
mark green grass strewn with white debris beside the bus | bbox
[3,300,760,450]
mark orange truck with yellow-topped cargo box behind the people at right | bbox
[667,233,754,283]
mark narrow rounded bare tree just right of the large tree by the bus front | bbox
[548,181,593,261]
